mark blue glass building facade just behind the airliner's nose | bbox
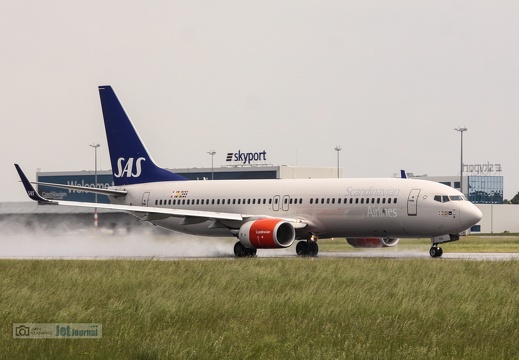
[468,176,503,204]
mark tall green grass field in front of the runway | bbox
[0,258,519,359]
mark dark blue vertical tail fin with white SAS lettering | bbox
[99,86,187,186]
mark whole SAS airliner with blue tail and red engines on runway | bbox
[15,86,482,257]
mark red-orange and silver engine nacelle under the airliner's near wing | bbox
[238,219,296,249]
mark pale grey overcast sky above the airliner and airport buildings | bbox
[0,0,519,201]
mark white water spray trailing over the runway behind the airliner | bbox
[0,220,243,259]
